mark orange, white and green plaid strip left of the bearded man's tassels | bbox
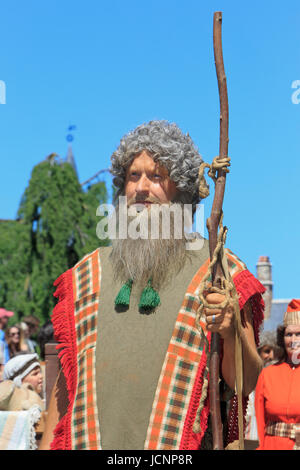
[71,250,101,450]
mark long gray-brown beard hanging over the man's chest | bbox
[110,204,188,290]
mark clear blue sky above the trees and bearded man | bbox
[0,0,300,298]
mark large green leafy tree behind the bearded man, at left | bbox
[0,155,107,323]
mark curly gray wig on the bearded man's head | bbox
[110,121,202,210]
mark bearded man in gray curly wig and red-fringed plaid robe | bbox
[40,121,264,450]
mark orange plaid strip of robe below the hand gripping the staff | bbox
[145,283,209,450]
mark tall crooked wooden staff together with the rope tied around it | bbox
[194,12,244,450]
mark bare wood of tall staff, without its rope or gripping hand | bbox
[207,12,229,450]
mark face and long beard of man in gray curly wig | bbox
[111,151,186,289]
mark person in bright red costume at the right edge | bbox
[255,299,300,450]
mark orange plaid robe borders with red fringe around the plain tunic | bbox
[51,244,264,450]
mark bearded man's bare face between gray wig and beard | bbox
[125,150,177,207]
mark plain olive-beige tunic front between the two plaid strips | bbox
[96,243,209,450]
